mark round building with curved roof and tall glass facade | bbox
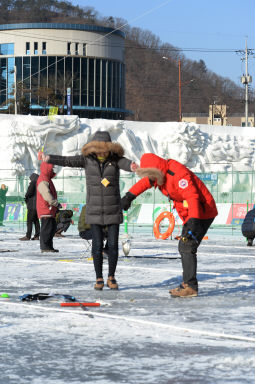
[0,23,129,119]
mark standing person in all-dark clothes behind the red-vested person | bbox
[20,173,40,241]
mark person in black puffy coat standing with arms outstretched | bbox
[38,131,137,290]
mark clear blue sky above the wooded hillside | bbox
[71,0,255,87]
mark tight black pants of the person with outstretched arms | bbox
[91,224,119,279]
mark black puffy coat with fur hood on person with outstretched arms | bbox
[48,131,132,225]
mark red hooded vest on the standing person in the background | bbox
[36,162,58,219]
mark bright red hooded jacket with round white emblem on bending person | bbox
[129,153,218,224]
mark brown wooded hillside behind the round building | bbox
[0,0,251,121]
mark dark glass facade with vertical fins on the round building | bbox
[0,55,125,118]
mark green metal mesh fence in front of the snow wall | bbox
[0,170,255,230]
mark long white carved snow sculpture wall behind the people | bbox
[0,115,255,194]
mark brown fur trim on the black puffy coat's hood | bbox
[81,140,124,157]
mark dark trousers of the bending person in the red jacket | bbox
[178,219,214,290]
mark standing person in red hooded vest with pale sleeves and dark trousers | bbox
[36,163,61,253]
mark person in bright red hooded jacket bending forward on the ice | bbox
[122,153,218,297]
